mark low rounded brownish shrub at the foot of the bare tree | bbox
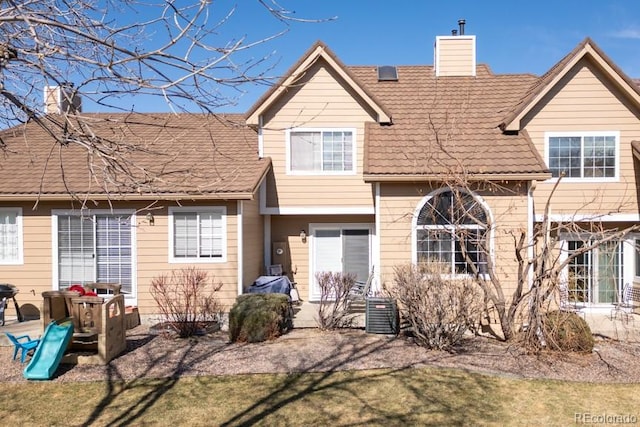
[542,311,594,353]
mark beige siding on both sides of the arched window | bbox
[379,183,528,300]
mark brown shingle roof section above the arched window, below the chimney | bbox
[349,65,548,180]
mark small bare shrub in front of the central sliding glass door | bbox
[316,272,356,330]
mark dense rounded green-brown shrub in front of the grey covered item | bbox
[229,294,293,342]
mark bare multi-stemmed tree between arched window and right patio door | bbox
[419,169,640,350]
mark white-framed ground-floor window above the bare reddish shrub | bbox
[169,207,227,262]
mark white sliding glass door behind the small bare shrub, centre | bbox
[309,224,373,301]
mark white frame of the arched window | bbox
[411,187,495,279]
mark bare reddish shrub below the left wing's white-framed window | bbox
[151,267,222,338]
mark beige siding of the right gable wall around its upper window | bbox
[523,59,640,215]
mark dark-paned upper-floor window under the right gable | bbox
[547,132,620,180]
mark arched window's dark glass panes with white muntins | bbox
[416,190,489,274]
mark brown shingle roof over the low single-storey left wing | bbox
[0,113,271,198]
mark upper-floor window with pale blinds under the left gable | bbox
[288,129,356,174]
